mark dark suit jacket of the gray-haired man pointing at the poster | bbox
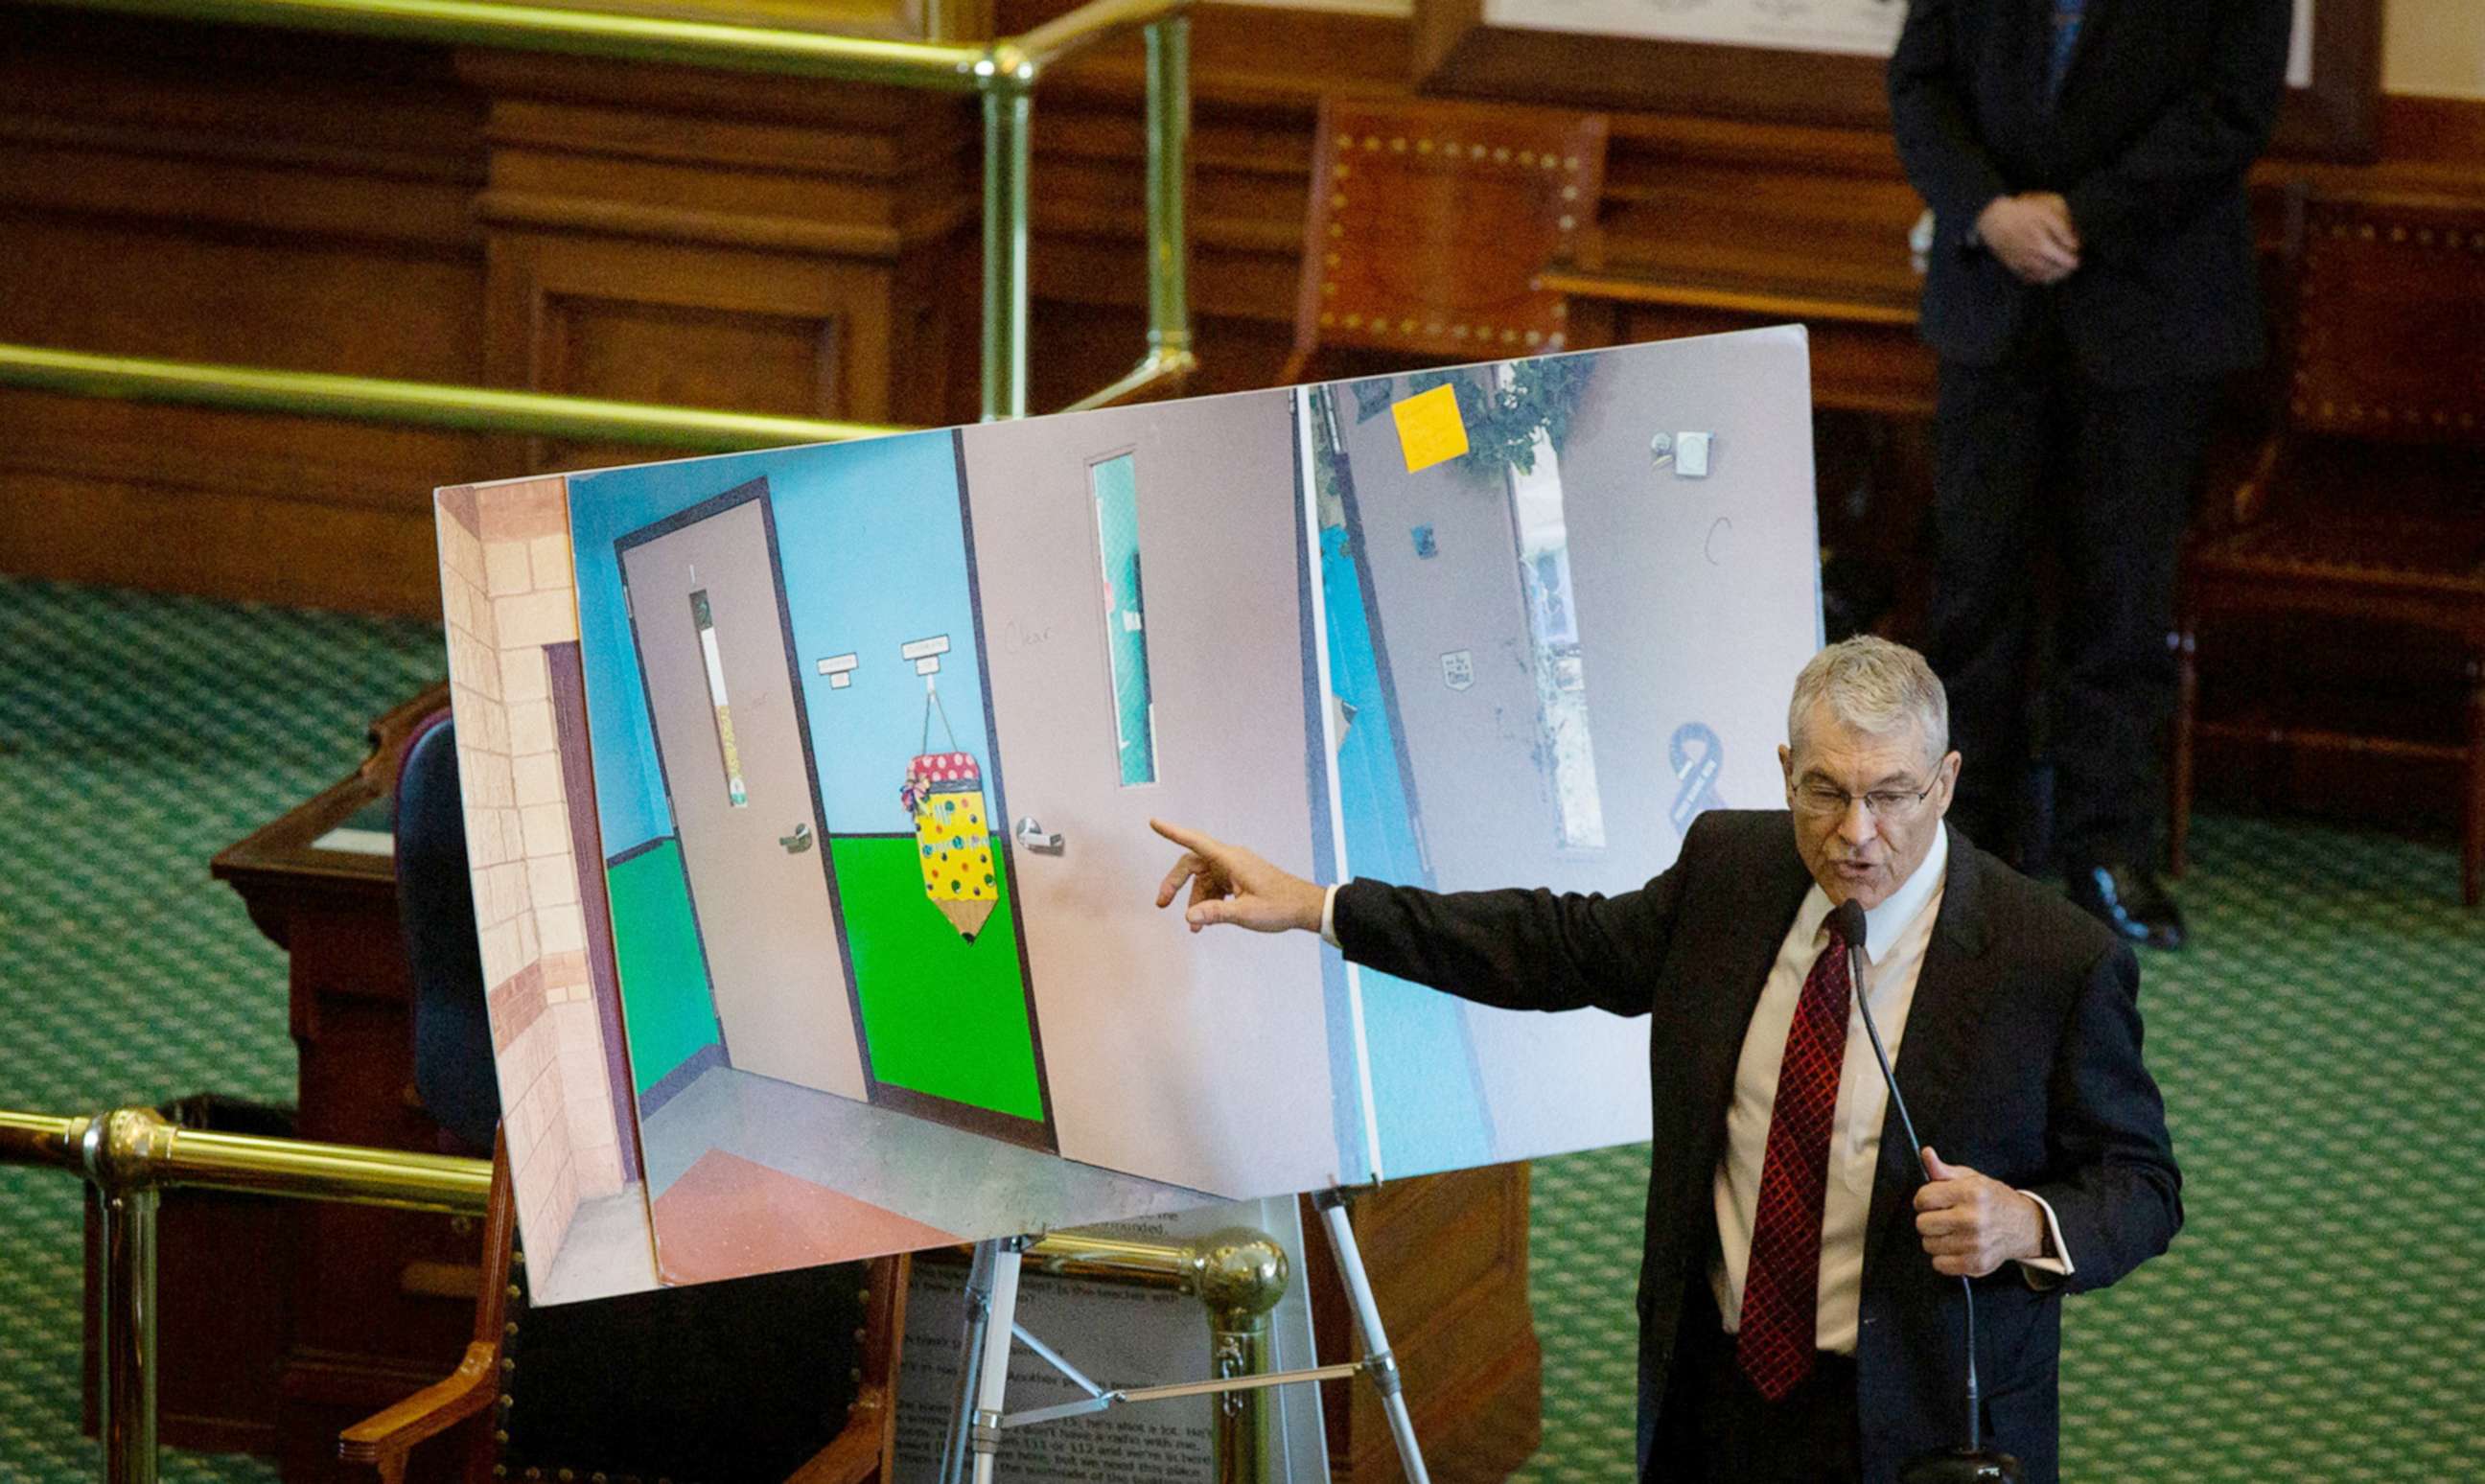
[1335,810,2182,1484]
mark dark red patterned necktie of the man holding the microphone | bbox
[1734,930,1848,1402]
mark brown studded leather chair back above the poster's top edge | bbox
[1277,97,1605,383]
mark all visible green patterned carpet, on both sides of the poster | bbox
[0,579,2485,1484]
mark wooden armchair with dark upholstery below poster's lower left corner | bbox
[338,1139,907,1484]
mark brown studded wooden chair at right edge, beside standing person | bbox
[2170,198,2485,907]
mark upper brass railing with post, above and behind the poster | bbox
[0,0,1197,429]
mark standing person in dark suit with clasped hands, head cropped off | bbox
[1889,0,2293,947]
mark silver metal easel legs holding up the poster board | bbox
[940,1191,1431,1484]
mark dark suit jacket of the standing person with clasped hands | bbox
[1889,0,2293,385]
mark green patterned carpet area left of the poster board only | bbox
[0,579,448,1484]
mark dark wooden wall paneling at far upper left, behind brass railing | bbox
[0,10,482,614]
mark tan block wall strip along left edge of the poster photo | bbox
[440,479,621,1263]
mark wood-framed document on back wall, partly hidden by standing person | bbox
[1414,0,2380,159]
